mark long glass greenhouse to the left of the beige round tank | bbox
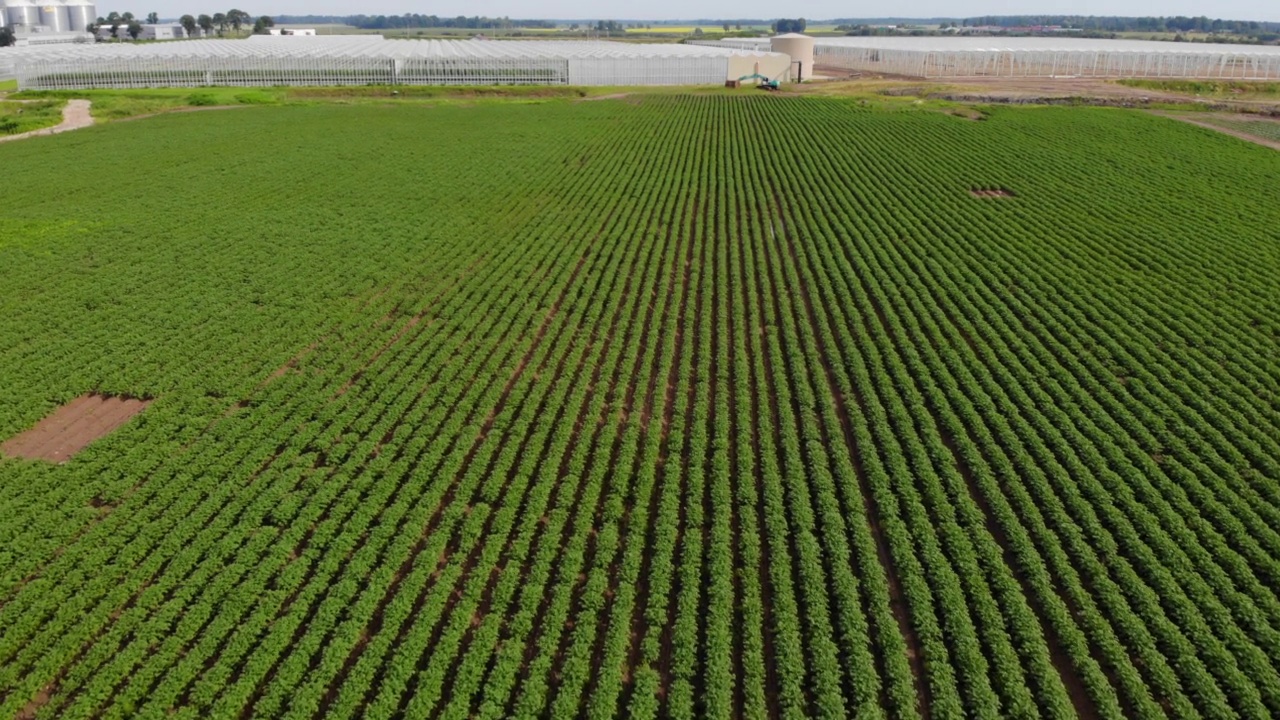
[0,36,774,90]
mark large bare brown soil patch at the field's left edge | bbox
[0,393,152,462]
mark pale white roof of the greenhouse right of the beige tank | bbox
[719,36,1280,55]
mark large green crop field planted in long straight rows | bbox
[0,91,1280,720]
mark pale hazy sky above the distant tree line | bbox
[132,0,1280,22]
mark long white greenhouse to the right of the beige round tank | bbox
[703,37,1280,79]
